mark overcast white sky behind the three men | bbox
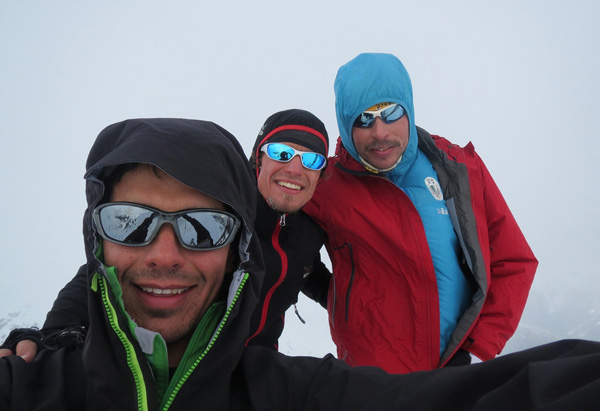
[0,0,600,355]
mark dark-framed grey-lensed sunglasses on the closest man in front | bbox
[93,202,240,251]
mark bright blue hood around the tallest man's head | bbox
[334,53,417,179]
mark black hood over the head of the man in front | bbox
[84,118,256,274]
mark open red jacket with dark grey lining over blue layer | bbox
[304,129,537,373]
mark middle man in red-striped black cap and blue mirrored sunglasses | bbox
[0,109,330,361]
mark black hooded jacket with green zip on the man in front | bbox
[0,119,600,411]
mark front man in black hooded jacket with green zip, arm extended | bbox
[0,119,600,410]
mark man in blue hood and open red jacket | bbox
[303,53,537,373]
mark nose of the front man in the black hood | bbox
[144,224,185,269]
